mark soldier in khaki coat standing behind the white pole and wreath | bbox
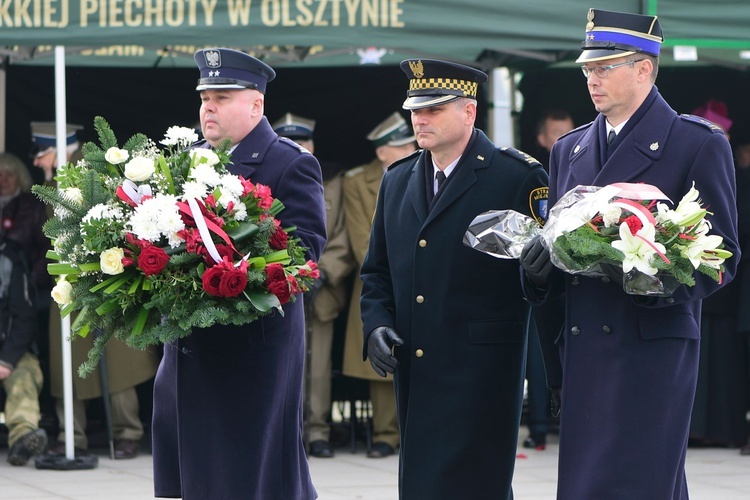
[31,122,158,459]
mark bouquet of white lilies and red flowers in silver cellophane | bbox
[464,183,732,296]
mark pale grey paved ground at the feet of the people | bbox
[0,431,750,500]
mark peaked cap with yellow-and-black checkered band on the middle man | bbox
[401,59,487,109]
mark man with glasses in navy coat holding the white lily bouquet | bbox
[521,9,739,500]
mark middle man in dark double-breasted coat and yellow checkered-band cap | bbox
[361,59,547,500]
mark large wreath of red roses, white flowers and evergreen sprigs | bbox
[33,117,319,376]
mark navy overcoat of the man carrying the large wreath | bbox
[153,118,326,500]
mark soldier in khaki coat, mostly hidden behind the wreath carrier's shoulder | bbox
[273,113,354,458]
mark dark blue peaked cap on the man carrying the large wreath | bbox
[195,48,276,93]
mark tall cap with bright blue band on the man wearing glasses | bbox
[576,9,664,63]
